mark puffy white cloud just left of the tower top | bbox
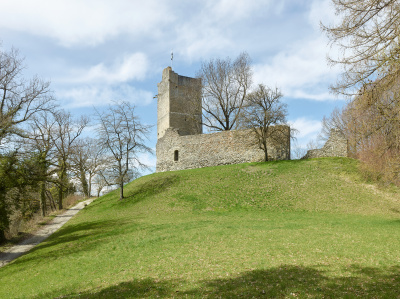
[73,53,149,83]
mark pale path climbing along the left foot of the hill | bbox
[0,198,94,268]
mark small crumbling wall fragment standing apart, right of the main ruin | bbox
[302,129,348,159]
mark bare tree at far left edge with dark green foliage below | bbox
[0,42,54,239]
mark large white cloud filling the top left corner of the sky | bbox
[0,0,173,46]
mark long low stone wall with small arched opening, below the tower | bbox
[156,126,290,172]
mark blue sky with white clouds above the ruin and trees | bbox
[0,0,346,169]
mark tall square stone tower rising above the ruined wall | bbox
[157,67,202,139]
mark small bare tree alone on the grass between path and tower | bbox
[97,102,151,200]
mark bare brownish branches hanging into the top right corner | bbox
[322,0,400,95]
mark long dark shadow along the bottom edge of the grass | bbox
[49,265,400,298]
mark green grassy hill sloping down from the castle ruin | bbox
[0,158,400,298]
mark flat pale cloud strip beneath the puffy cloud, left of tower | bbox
[57,84,153,108]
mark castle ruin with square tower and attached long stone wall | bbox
[156,67,290,172]
